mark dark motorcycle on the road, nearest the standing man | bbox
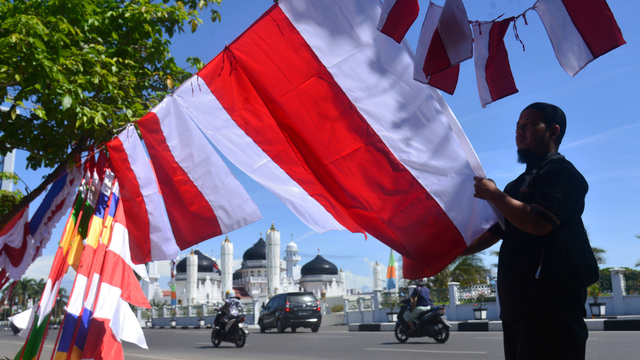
[394,299,451,344]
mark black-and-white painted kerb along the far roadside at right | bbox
[349,315,640,332]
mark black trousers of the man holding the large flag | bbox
[502,306,589,360]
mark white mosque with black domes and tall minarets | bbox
[142,223,347,305]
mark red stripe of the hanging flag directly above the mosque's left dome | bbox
[138,110,222,250]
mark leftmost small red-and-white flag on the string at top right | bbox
[378,0,420,43]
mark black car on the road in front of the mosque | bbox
[258,292,322,333]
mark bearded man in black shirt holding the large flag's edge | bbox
[462,103,591,360]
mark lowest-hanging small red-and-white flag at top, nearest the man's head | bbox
[473,18,518,107]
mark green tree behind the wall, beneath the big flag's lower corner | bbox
[429,254,489,288]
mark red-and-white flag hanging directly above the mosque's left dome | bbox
[138,96,262,250]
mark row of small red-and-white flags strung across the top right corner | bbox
[378,0,625,107]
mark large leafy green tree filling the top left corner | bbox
[0,0,222,227]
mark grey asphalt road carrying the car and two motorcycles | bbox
[0,326,640,360]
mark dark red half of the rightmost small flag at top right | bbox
[562,0,626,58]
